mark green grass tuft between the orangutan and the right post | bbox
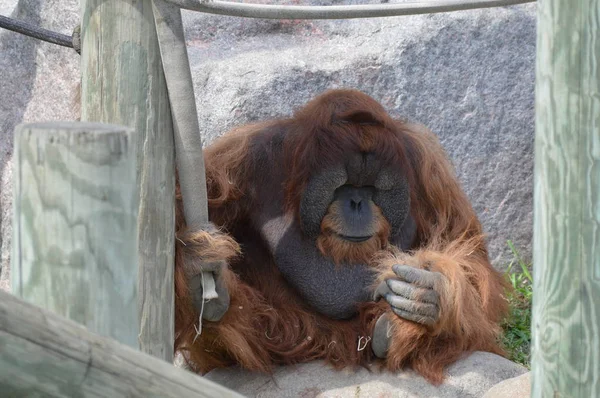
[502,240,533,368]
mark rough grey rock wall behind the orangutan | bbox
[0,0,536,288]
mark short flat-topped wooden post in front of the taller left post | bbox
[12,123,139,348]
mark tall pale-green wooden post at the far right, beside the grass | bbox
[532,0,600,398]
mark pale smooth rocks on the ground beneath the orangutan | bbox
[205,352,527,398]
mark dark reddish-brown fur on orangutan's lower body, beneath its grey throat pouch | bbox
[176,238,376,373]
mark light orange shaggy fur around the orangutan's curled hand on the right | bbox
[376,237,506,383]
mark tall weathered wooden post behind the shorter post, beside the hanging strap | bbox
[81,0,175,362]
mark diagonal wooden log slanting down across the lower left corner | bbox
[0,291,246,398]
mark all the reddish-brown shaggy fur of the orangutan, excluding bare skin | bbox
[175,90,507,383]
